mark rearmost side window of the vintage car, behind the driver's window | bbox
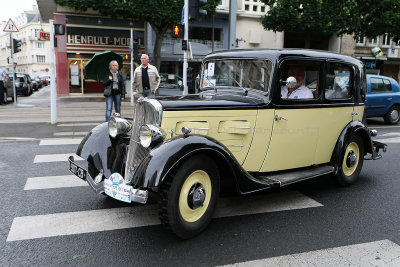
[324,63,353,100]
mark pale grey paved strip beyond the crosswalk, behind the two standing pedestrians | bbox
[0,86,133,124]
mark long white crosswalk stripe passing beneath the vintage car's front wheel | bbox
[7,192,323,241]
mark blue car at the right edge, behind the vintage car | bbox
[365,75,400,124]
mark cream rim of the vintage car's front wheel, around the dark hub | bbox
[179,170,212,222]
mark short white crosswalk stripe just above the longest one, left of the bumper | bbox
[24,175,88,190]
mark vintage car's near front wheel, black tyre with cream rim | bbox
[159,156,219,239]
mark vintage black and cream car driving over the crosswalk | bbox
[69,50,386,238]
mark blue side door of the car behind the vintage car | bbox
[366,75,393,116]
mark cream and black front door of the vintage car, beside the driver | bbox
[260,59,323,172]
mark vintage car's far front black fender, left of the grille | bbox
[76,122,129,180]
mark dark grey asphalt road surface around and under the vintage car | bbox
[0,119,400,266]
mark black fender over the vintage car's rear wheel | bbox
[331,121,375,174]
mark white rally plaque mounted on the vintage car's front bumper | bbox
[104,173,132,203]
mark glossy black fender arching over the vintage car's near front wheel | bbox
[132,135,269,194]
